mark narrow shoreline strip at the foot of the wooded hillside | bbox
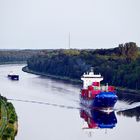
[22,66,140,95]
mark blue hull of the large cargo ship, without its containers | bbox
[80,92,118,109]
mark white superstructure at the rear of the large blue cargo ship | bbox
[81,68,103,89]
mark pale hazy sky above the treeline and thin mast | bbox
[0,0,140,49]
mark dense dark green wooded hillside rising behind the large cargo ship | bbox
[27,42,140,89]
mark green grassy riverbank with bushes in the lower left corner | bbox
[0,96,18,140]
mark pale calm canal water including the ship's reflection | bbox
[0,65,140,140]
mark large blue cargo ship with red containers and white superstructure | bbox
[80,68,118,110]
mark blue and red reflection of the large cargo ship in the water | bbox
[80,109,117,129]
